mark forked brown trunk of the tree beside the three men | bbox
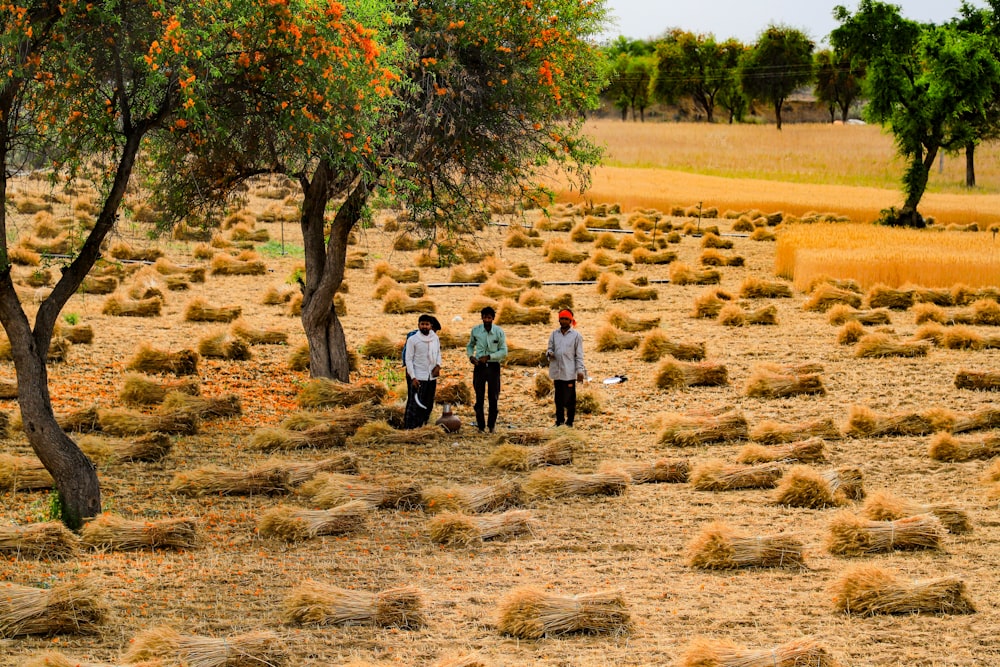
[301,162,372,382]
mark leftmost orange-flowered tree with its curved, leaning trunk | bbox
[0,0,398,527]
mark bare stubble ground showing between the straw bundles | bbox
[0,175,1000,667]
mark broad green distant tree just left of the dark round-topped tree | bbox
[653,31,743,123]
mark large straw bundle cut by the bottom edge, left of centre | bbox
[124,625,287,667]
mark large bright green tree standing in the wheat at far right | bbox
[831,0,1000,227]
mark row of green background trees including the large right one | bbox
[603,0,1000,227]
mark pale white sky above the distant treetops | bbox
[606,0,985,45]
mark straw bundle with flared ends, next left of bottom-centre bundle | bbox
[282,581,426,629]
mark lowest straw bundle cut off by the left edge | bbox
[0,580,109,639]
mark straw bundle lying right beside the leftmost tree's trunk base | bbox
[80,512,198,551]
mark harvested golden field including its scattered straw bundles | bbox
[0,126,1000,667]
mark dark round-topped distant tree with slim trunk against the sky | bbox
[739,25,813,130]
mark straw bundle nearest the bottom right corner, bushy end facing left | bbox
[832,565,976,616]
